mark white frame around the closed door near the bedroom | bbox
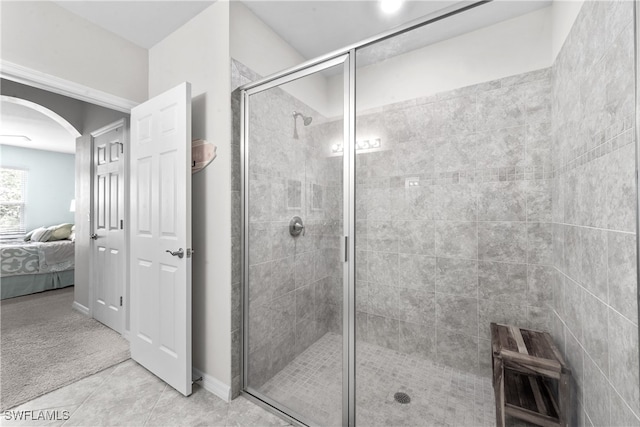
[89,118,130,340]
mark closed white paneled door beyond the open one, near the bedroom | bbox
[91,119,126,333]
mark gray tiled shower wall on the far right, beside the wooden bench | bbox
[552,1,640,426]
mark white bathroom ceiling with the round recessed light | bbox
[52,0,552,59]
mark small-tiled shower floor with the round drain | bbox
[260,333,495,426]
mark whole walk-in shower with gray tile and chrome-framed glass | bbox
[238,2,640,426]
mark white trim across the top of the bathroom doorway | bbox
[0,60,139,113]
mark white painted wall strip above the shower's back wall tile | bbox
[329,7,553,115]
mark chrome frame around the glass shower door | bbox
[240,50,355,426]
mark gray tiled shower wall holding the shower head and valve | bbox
[232,61,342,398]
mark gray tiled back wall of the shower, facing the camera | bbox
[356,69,553,375]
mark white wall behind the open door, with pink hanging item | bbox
[149,1,231,394]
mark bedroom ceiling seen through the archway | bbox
[0,100,76,153]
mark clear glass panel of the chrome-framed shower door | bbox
[243,56,346,425]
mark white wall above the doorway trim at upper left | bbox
[0,1,148,102]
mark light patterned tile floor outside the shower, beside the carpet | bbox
[0,360,289,427]
